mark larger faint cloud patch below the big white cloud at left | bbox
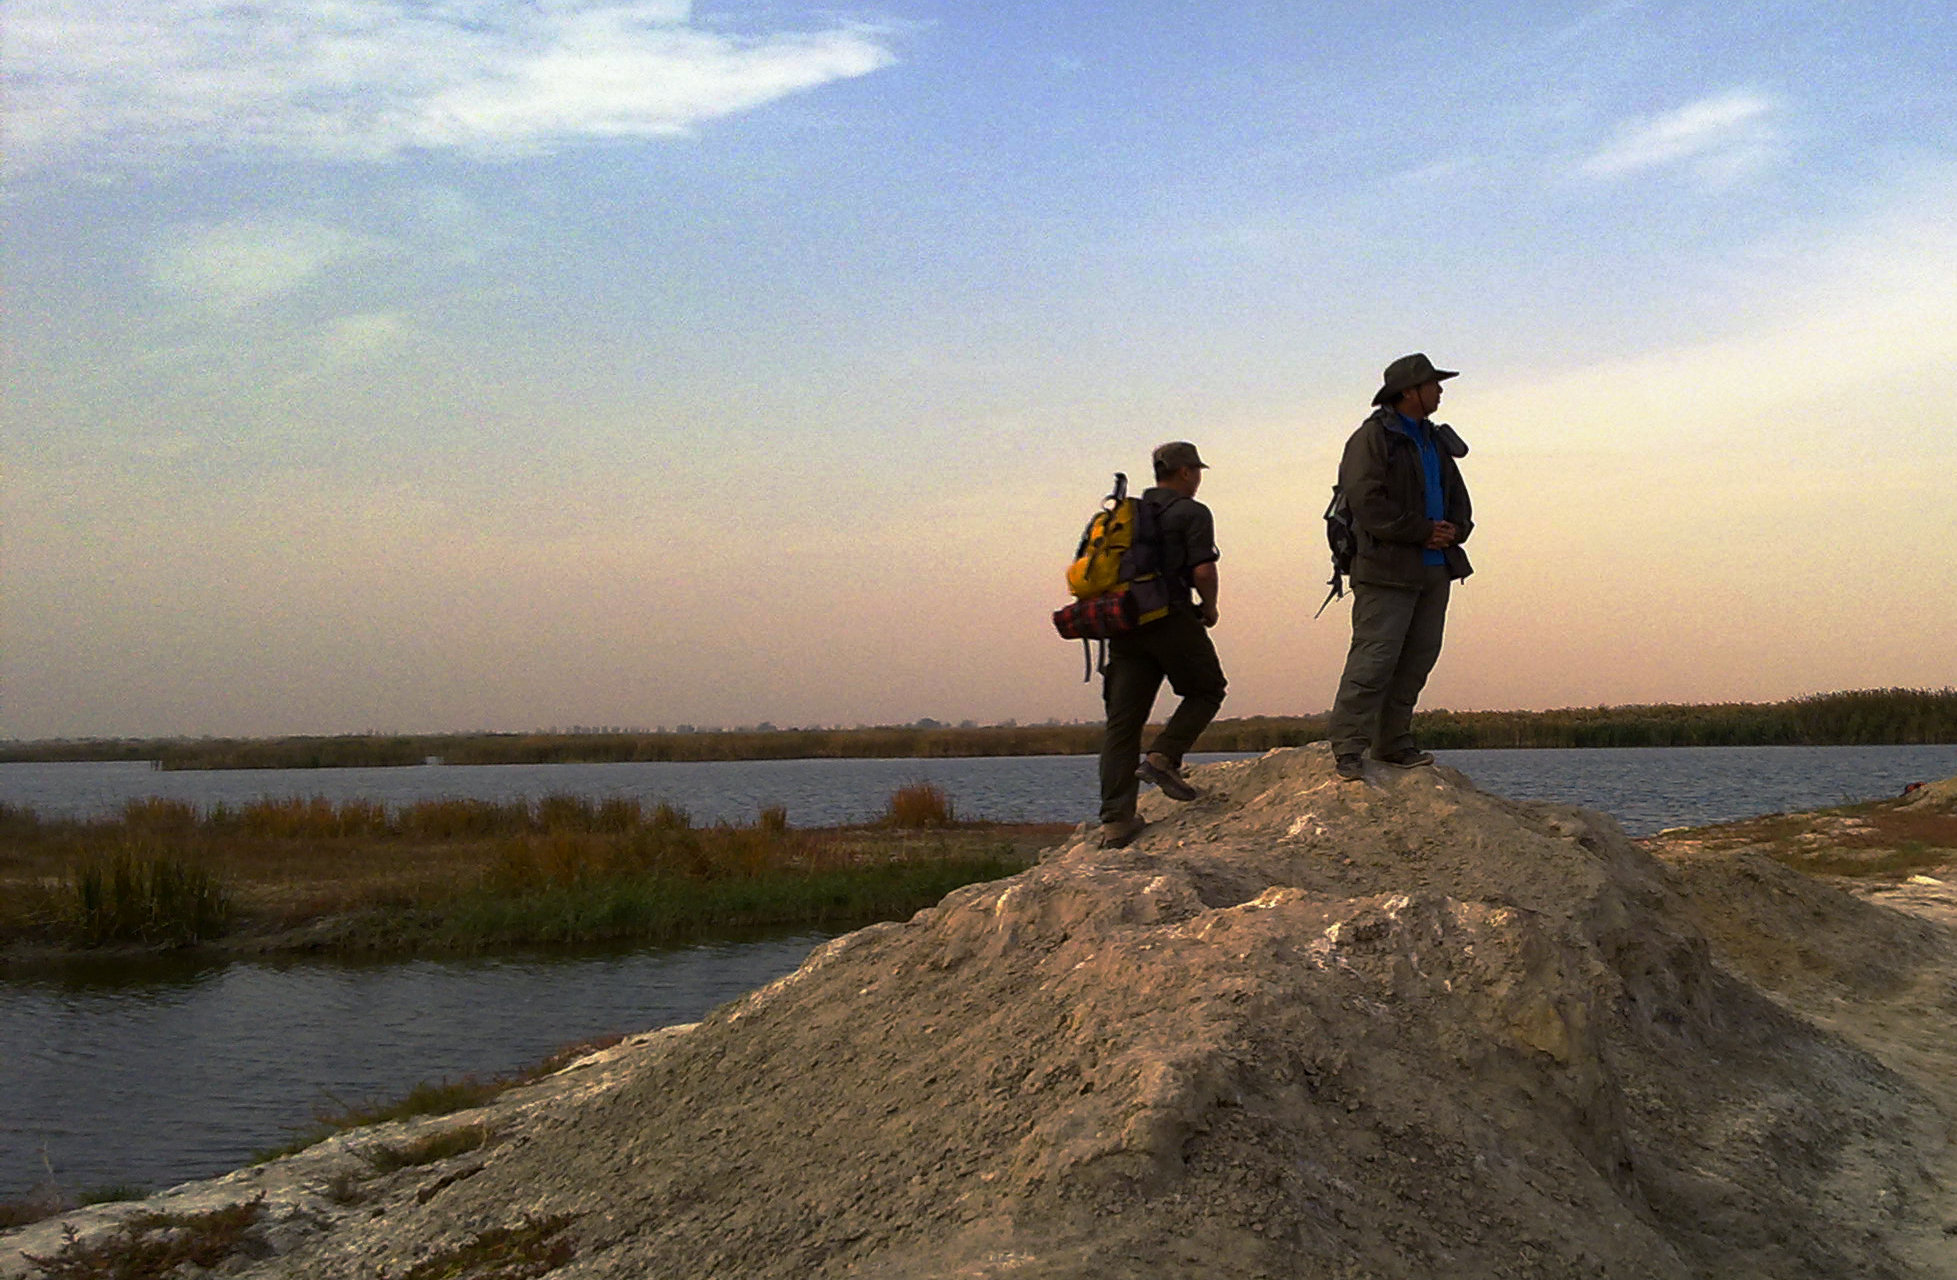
[151,217,384,315]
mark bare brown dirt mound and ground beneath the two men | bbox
[0,746,1957,1280]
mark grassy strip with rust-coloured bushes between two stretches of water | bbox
[0,783,1069,961]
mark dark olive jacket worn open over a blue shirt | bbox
[1339,407,1474,587]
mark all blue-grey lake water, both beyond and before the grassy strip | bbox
[0,746,1957,1198]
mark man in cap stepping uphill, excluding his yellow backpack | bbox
[1100,440,1225,847]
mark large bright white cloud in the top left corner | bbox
[8,0,894,170]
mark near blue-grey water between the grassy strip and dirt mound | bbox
[0,934,826,1196]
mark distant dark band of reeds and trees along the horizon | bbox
[0,689,1957,769]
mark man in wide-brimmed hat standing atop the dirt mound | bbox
[1331,352,1474,779]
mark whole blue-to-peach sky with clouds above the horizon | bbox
[0,0,1957,740]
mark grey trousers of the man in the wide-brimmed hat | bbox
[1331,564,1452,755]
